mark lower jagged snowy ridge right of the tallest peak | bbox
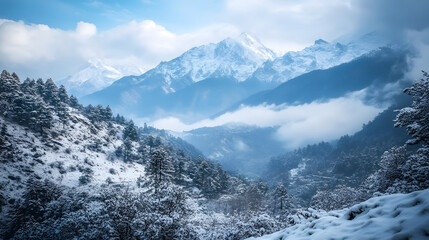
[252,34,385,83]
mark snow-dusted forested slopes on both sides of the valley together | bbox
[0,68,429,239]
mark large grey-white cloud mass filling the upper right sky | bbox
[222,0,429,51]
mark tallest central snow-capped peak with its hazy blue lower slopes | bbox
[81,33,275,117]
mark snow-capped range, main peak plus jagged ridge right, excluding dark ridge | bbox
[81,33,378,122]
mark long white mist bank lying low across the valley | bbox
[153,96,383,148]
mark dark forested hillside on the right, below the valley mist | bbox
[265,73,429,210]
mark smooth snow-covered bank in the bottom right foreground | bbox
[250,189,429,240]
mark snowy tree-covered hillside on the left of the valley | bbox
[0,71,294,239]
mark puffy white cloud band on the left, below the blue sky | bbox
[0,19,239,80]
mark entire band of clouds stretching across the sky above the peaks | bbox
[0,0,429,79]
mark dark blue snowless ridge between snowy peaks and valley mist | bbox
[224,47,408,112]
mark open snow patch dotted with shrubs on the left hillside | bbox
[0,108,145,198]
